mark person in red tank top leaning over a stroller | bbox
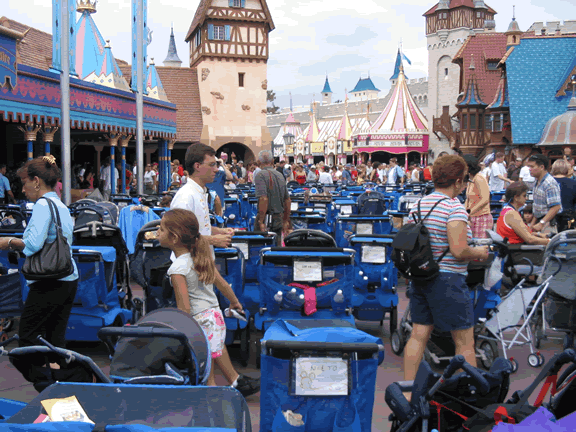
[496,181,550,245]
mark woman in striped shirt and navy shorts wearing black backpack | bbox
[404,155,488,396]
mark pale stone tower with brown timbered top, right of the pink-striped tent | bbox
[424,0,496,156]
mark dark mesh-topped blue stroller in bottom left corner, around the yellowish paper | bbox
[7,383,251,432]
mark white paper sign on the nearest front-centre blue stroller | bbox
[294,357,348,396]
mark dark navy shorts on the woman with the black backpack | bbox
[410,272,474,332]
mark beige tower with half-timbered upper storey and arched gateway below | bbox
[186,0,274,162]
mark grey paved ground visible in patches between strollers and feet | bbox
[0,287,562,431]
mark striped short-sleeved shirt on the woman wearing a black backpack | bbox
[408,192,472,275]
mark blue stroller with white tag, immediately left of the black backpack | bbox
[350,235,398,334]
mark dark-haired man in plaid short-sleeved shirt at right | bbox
[528,154,562,231]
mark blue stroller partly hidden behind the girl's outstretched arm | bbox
[214,247,250,366]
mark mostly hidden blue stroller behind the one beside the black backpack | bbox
[334,215,392,247]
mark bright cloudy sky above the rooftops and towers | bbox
[5,0,576,108]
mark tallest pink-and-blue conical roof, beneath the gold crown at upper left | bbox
[76,8,106,79]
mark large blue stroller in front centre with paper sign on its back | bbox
[260,319,384,432]
